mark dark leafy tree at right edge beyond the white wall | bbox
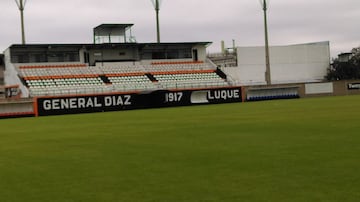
[326,47,360,81]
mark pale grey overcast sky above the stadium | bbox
[0,0,360,56]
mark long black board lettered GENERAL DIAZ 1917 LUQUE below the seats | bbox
[35,87,242,116]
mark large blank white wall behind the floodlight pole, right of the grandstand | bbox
[232,42,330,85]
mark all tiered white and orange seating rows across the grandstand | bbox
[19,61,228,96]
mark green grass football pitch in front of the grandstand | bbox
[0,96,360,202]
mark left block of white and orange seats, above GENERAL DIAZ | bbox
[19,64,109,96]
